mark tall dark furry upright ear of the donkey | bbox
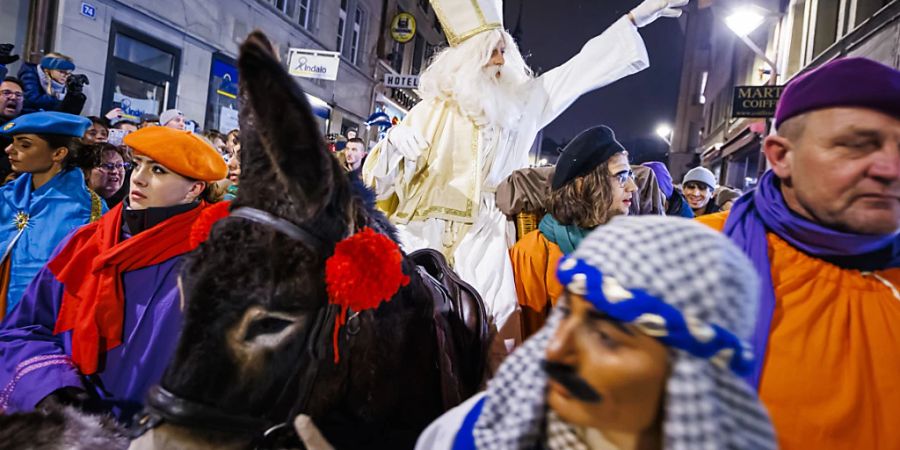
[238,31,335,216]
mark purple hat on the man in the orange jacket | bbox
[775,58,900,127]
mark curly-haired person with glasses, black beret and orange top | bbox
[510,125,637,338]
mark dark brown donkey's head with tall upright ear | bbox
[162,32,441,444]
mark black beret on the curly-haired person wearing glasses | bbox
[552,125,625,191]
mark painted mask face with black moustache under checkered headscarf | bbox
[544,294,669,433]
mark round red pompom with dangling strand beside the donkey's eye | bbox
[325,227,409,364]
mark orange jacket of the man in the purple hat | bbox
[696,212,900,450]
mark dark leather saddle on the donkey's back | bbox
[408,248,490,409]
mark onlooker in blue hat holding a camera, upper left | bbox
[19,52,87,114]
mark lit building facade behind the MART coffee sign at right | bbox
[669,0,900,189]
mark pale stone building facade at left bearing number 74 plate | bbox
[0,0,384,134]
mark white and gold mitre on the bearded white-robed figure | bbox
[431,0,503,47]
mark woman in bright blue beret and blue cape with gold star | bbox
[0,112,106,318]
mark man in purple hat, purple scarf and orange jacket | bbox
[698,58,900,450]
